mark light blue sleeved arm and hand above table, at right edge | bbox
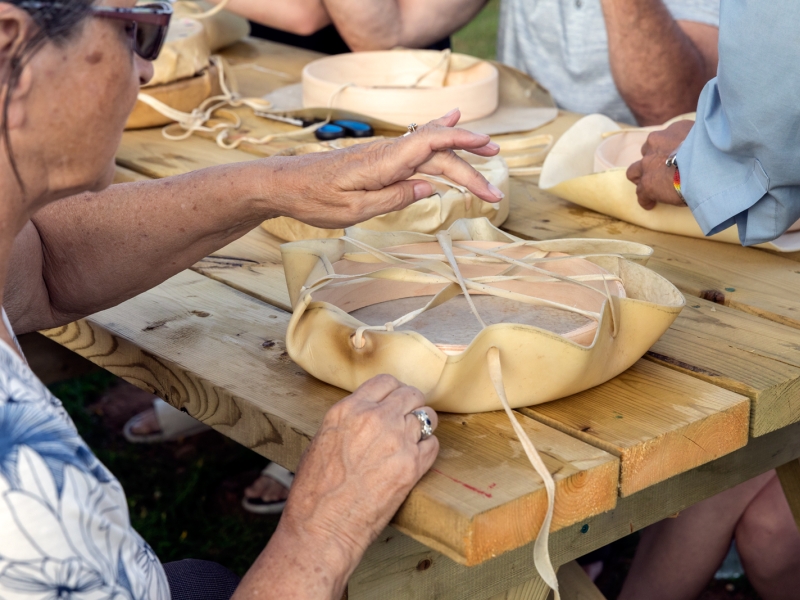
[628,0,800,246]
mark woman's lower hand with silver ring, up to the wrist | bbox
[281,375,439,565]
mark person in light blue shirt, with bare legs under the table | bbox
[619,0,800,600]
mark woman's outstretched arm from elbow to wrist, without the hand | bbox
[5,163,268,333]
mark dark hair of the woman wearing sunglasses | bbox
[2,0,94,192]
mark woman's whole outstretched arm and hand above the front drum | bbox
[3,115,502,333]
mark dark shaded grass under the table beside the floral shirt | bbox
[51,371,277,575]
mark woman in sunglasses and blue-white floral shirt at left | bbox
[0,0,501,599]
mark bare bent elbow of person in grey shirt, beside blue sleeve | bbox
[603,0,718,125]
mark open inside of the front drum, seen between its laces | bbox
[314,241,625,354]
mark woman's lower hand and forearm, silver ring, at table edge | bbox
[235,375,439,600]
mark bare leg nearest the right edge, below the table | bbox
[736,471,800,600]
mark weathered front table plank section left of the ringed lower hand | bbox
[44,273,324,467]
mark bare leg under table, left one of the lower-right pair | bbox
[619,472,776,600]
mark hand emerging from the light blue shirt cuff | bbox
[627,121,694,210]
